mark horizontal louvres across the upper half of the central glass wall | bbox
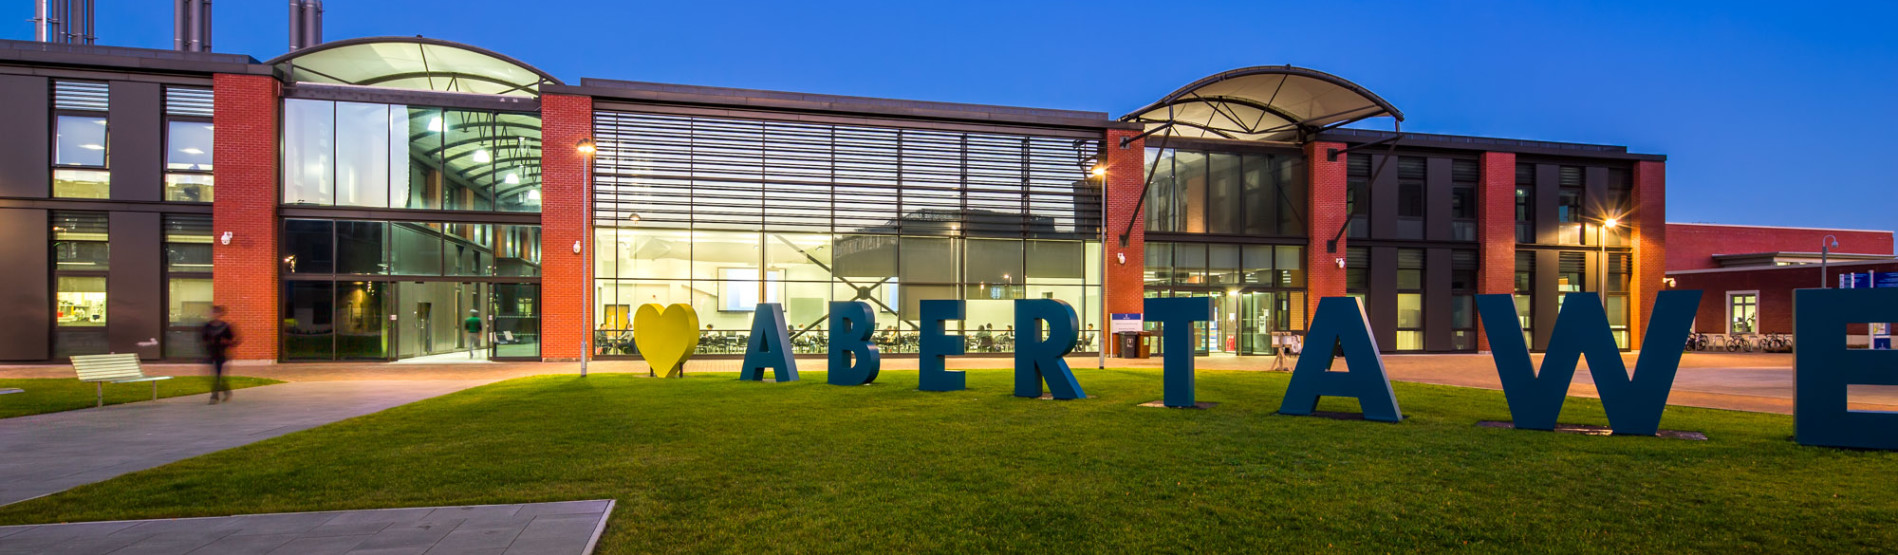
[594,112,1101,238]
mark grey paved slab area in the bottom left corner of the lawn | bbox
[0,500,613,555]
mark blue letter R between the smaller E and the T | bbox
[1015,298,1088,399]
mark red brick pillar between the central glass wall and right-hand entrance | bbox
[1101,129,1146,353]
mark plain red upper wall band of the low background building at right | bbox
[1666,224,1892,270]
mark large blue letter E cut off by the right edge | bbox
[1792,289,1898,449]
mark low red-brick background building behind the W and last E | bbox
[1666,224,1898,335]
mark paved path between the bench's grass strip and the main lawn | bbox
[0,380,486,506]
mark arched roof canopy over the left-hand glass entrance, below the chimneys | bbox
[270,36,560,97]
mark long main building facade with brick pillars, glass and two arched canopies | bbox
[0,38,1666,361]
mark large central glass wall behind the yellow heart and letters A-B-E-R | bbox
[594,112,1101,355]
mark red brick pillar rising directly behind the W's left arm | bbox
[1477,152,1517,352]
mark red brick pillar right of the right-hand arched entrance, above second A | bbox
[1306,141,1351,327]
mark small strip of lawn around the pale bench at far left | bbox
[0,376,281,418]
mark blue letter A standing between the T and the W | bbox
[1279,297,1405,422]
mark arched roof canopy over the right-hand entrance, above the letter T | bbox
[1120,65,1405,143]
